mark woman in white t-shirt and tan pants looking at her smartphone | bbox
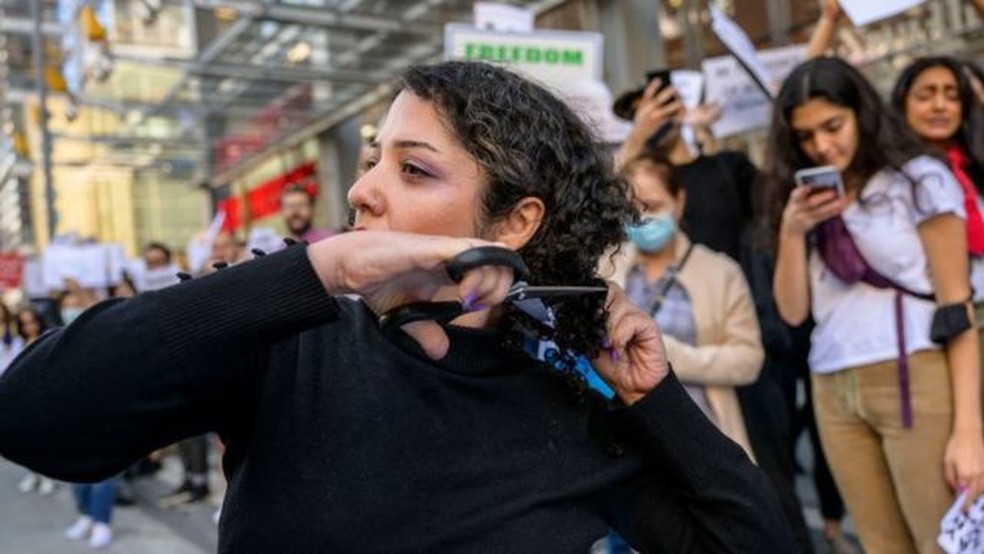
[766,58,984,552]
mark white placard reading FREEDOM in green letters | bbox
[444,23,603,84]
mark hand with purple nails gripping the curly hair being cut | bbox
[591,284,670,405]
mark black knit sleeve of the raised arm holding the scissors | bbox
[0,246,336,481]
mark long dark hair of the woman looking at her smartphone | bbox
[759,57,927,246]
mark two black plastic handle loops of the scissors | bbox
[379,246,529,335]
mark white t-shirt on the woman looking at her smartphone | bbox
[809,156,965,373]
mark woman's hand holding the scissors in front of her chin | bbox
[308,231,513,359]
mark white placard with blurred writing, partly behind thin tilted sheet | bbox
[701,45,806,138]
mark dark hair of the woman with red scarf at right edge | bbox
[891,56,984,185]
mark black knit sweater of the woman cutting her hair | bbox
[0,247,791,554]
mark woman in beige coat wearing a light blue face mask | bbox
[602,149,765,460]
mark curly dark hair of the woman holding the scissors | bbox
[399,62,636,362]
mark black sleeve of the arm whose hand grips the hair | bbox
[605,373,795,553]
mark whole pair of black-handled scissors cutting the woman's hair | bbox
[379,246,608,334]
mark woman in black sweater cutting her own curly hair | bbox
[0,62,789,553]
